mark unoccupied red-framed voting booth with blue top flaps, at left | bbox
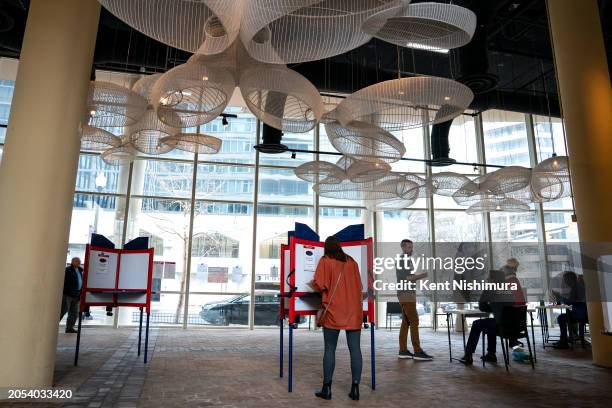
[74,239,154,366]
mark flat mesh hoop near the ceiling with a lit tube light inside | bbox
[363,3,476,51]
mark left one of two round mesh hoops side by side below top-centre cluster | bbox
[151,56,236,128]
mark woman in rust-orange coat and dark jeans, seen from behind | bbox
[310,236,363,400]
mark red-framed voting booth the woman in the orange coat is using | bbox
[280,223,376,392]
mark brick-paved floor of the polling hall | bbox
[2,328,612,408]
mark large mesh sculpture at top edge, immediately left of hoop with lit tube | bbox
[240,0,400,64]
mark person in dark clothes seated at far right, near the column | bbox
[552,271,588,349]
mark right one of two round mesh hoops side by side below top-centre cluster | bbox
[240,64,323,133]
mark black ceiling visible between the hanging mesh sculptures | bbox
[0,0,612,116]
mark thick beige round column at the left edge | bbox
[0,0,100,387]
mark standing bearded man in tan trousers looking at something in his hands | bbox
[396,239,433,361]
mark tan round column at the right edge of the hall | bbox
[548,0,612,367]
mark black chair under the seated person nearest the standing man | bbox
[482,306,535,371]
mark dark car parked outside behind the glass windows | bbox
[200,291,279,326]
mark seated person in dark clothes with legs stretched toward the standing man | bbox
[459,270,522,365]
